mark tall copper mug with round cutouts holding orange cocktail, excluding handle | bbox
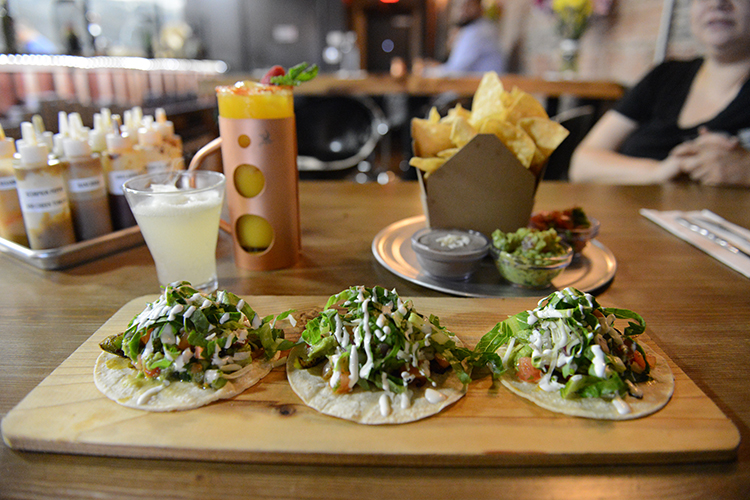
[216,81,300,270]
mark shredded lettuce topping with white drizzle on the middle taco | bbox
[300,286,471,394]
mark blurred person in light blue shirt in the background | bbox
[424,0,505,77]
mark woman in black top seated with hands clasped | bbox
[570,0,750,186]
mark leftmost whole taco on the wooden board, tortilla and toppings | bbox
[94,282,294,411]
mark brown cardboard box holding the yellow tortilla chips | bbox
[417,134,538,237]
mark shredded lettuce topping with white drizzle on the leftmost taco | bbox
[100,282,296,389]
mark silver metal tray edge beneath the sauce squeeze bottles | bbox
[0,226,144,270]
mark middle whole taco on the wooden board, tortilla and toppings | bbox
[287,286,470,424]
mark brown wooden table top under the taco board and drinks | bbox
[0,181,750,500]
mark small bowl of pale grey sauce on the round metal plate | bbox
[411,228,490,280]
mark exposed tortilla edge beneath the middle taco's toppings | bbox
[286,345,466,425]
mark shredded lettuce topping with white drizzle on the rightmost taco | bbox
[471,288,649,399]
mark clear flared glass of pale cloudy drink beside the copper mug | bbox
[123,170,226,292]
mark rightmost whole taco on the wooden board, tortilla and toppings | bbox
[475,288,674,420]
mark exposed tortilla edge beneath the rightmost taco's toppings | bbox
[500,344,674,420]
